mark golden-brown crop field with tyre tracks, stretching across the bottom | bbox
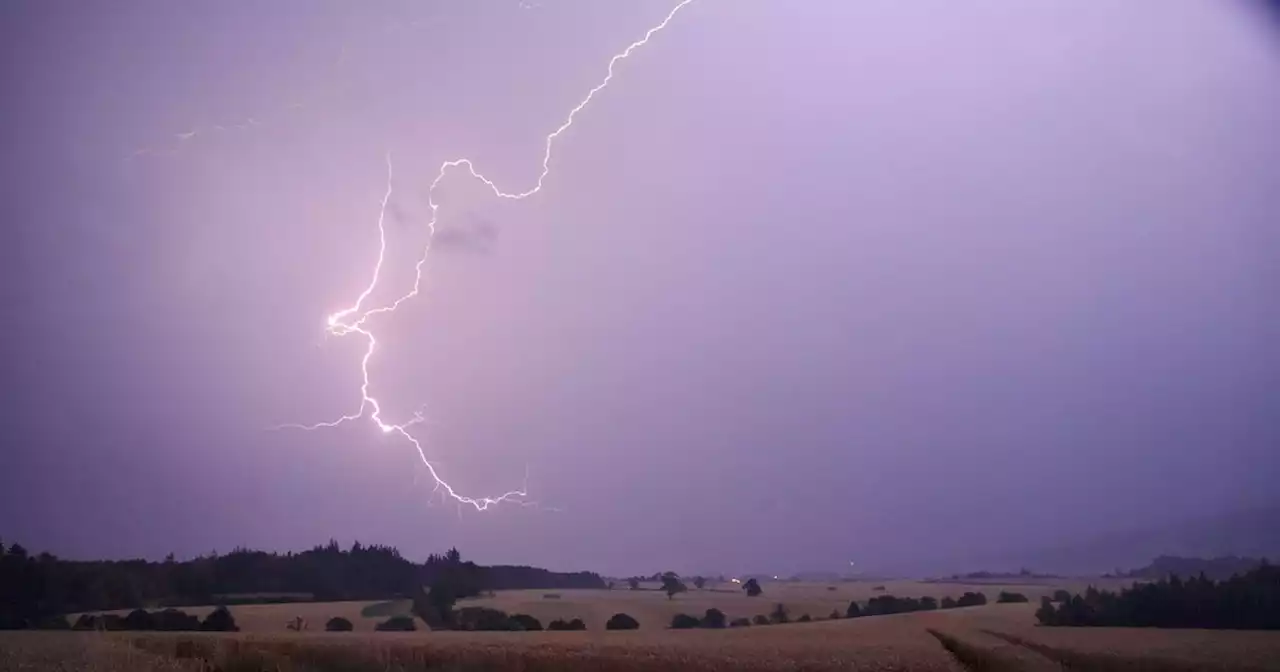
[22,582,1280,672]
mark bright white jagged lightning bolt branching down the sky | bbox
[280,0,694,512]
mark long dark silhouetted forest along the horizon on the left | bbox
[0,540,605,628]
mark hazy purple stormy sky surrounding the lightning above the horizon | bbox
[0,0,1280,573]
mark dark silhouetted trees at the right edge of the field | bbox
[1036,562,1280,630]
